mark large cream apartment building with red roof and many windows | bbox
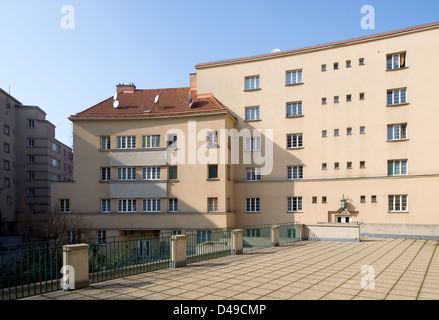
[52,23,439,237]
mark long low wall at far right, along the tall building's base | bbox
[361,223,439,240]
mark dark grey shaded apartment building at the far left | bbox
[0,89,73,235]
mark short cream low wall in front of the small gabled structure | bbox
[302,224,360,242]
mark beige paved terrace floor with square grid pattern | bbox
[23,238,439,300]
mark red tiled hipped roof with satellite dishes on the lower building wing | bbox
[70,87,234,120]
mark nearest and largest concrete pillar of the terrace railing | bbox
[61,244,90,290]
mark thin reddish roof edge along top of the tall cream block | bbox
[195,22,439,69]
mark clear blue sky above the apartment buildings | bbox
[0,0,439,146]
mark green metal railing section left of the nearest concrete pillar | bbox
[0,242,63,300]
